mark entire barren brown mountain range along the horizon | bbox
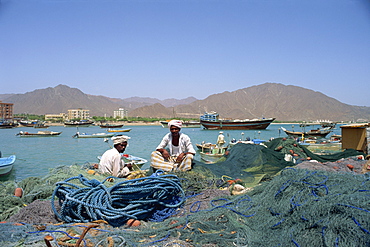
[0,83,370,122]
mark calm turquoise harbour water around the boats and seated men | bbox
[0,124,341,181]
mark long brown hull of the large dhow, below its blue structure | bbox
[200,118,275,130]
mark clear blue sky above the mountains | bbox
[0,0,370,106]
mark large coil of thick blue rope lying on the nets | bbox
[51,174,186,227]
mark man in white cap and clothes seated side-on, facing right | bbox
[99,135,132,178]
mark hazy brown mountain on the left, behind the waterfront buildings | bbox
[0,85,197,116]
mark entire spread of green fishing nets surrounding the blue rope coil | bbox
[0,139,370,247]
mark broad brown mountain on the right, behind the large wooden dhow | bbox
[130,83,370,121]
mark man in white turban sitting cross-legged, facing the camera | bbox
[150,120,195,171]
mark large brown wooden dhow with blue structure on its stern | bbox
[200,112,275,130]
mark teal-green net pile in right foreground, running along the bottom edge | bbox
[0,168,370,247]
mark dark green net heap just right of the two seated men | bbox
[194,138,363,187]
